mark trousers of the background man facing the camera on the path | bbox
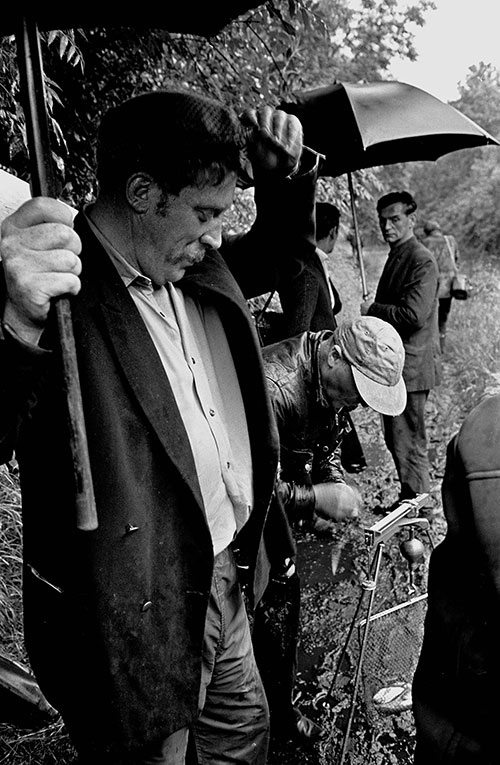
[383,390,430,499]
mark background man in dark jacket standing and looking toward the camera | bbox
[361,191,440,501]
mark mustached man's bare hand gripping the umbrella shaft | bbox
[0,197,82,344]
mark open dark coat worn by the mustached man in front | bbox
[0,217,277,747]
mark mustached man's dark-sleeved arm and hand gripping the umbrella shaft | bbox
[0,197,81,463]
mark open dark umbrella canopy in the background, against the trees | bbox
[281,82,500,177]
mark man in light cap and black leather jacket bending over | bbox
[253,316,406,740]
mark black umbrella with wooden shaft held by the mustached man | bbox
[4,0,263,531]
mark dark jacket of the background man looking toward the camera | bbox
[368,237,440,393]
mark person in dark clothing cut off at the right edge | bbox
[412,394,500,765]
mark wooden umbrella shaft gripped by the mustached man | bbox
[16,17,97,531]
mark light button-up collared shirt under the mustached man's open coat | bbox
[87,216,253,555]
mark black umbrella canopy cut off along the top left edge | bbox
[0,0,262,36]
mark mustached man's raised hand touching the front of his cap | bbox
[241,106,302,175]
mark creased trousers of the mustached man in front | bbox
[72,548,269,765]
